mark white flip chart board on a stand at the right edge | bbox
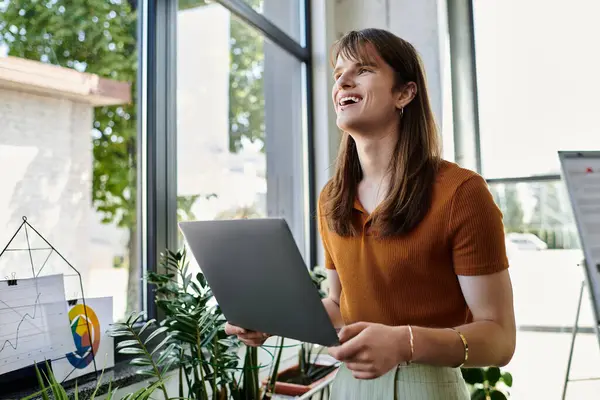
[558,151,600,328]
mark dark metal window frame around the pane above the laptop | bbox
[138,0,317,320]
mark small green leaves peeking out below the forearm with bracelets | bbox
[461,367,513,400]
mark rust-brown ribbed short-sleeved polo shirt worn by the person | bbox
[318,161,508,327]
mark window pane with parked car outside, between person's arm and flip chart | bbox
[491,181,592,326]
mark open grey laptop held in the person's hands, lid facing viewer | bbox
[179,218,339,346]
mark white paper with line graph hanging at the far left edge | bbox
[0,275,75,374]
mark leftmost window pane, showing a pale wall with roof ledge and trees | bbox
[0,0,141,320]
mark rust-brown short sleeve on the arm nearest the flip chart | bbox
[449,175,508,275]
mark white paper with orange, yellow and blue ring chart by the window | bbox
[52,297,115,382]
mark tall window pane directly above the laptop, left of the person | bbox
[177,4,305,256]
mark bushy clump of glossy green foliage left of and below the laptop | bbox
[110,248,260,400]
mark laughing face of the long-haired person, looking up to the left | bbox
[332,48,404,133]
